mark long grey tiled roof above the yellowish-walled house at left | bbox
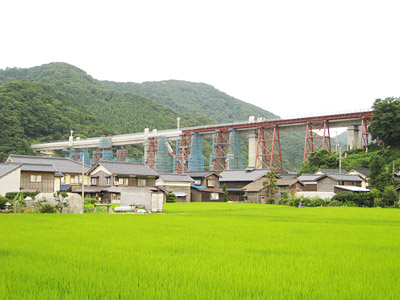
[9,154,90,174]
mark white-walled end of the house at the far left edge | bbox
[0,164,21,196]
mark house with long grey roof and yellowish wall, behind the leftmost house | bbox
[7,154,90,190]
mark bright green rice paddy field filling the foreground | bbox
[0,203,400,300]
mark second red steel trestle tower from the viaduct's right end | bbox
[303,120,332,162]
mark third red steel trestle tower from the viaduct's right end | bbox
[255,125,282,172]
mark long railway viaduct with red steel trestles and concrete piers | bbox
[32,110,373,173]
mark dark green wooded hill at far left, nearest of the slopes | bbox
[0,81,115,161]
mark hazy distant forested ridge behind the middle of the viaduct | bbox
[102,80,277,122]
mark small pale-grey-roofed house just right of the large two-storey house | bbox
[155,174,194,202]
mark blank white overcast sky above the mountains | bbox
[0,0,400,117]
